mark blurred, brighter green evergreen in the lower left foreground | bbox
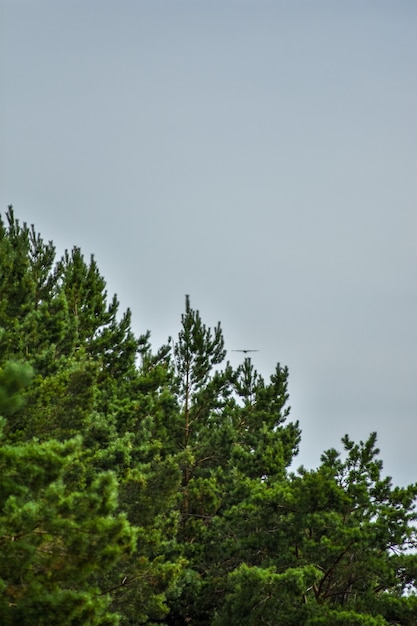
[0,364,135,626]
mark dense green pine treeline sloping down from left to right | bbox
[0,207,417,626]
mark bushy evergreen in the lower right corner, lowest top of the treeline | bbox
[214,433,417,626]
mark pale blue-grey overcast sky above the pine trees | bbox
[0,0,417,485]
